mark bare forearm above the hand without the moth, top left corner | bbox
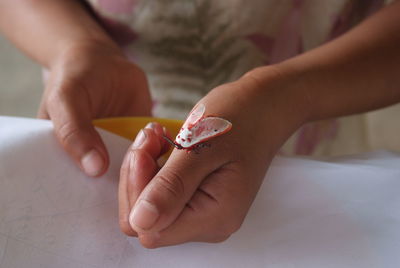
[0,0,116,67]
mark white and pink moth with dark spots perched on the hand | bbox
[164,103,232,152]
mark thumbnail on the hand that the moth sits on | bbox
[129,199,159,230]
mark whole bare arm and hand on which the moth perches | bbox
[119,2,400,248]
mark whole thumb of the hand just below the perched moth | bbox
[129,149,219,233]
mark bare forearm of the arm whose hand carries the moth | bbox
[250,2,400,121]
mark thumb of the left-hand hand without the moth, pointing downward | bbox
[48,90,109,177]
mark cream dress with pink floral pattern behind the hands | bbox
[83,0,396,155]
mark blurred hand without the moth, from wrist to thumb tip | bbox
[38,44,151,176]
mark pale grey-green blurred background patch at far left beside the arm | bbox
[0,34,43,117]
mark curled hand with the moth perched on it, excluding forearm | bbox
[119,68,305,248]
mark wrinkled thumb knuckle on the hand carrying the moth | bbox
[156,170,185,198]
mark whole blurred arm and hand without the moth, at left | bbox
[0,0,152,177]
